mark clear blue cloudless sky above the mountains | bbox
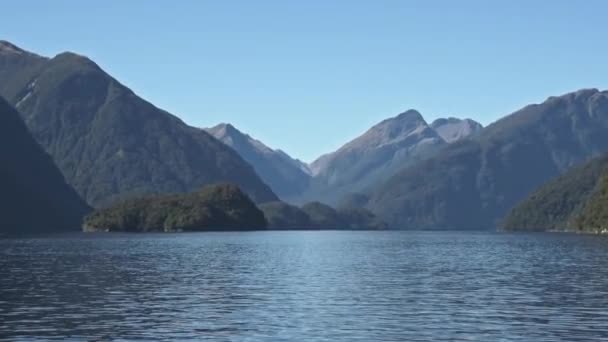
[0,0,608,161]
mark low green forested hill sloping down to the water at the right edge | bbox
[499,156,608,231]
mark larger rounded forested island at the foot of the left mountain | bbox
[83,184,267,232]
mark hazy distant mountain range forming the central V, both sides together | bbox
[206,110,482,205]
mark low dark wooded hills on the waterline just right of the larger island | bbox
[260,202,386,230]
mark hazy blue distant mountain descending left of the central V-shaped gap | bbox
[207,124,310,198]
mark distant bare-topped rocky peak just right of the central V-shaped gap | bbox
[302,110,447,204]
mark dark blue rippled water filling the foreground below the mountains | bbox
[0,232,608,341]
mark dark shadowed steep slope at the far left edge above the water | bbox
[0,98,90,234]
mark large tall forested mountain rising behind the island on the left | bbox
[0,41,277,206]
